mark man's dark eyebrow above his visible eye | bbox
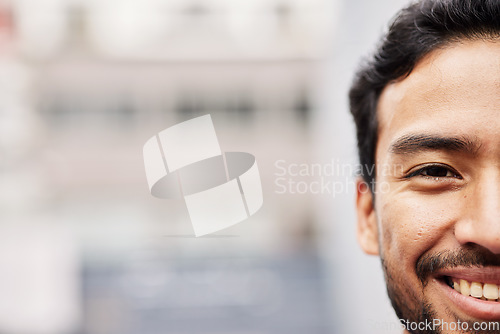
[389,134,481,155]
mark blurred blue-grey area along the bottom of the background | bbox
[84,255,329,334]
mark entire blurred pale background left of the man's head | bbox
[0,0,406,334]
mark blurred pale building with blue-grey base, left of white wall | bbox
[0,0,335,334]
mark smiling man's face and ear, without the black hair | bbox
[357,40,500,333]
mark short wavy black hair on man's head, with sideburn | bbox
[349,0,500,192]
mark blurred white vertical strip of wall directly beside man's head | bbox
[312,0,407,334]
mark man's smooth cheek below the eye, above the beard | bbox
[378,193,457,269]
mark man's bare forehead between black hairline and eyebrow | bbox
[376,39,500,158]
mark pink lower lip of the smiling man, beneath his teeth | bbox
[436,279,500,320]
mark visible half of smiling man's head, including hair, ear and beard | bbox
[350,0,500,333]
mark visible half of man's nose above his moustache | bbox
[455,170,500,254]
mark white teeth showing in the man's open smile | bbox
[442,276,500,303]
